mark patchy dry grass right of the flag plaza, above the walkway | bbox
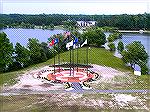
[91,74,150,90]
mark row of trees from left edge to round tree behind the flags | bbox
[0,30,106,72]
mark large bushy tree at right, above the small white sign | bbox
[121,41,148,70]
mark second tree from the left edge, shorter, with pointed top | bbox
[15,43,30,67]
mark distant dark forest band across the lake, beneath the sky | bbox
[0,13,150,30]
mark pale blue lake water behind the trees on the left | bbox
[0,28,64,46]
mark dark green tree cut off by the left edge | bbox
[0,33,14,72]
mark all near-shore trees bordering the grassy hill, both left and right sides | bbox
[0,28,149,74]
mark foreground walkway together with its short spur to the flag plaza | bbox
[0,82,150,96]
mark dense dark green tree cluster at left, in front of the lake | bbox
[0,32,57,72]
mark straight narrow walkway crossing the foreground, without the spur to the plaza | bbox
[0,89,150,96]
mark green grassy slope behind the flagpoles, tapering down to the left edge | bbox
[0,48,131,85]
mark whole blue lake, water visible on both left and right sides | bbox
[0,28,150,66]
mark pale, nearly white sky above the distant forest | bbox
[0,0,150,15]
